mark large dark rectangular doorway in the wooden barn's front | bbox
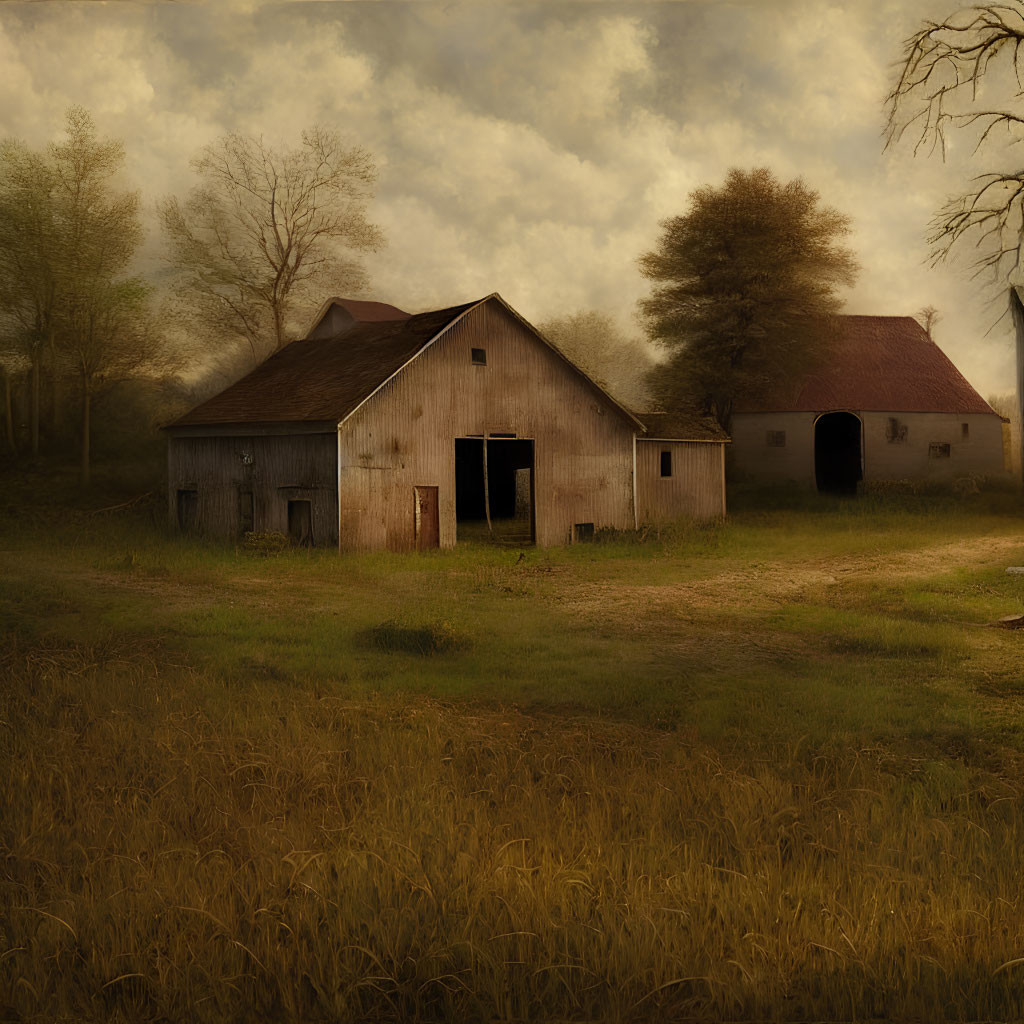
[455,437,534,544]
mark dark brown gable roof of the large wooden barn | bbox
[170,292,643,429]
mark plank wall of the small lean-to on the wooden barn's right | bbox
[637,438,725,523]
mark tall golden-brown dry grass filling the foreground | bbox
[0,638,1024,1022]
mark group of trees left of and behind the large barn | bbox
[0,106,383,484]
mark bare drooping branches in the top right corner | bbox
[886,0,1024,281]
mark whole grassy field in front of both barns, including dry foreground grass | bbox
[0,481,1024,1021]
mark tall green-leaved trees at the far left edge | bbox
[0,106,175,483]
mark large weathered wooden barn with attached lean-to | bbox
[167,294,727,551]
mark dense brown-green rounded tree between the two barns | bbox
[639,168,857,430]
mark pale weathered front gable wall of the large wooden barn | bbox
[338,301,633,550]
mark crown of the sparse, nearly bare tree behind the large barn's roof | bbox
[159,127,383,359]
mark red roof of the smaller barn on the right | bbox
[734,316,995,416]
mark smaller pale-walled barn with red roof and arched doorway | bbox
[732,316,1004,493]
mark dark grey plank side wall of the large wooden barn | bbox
[168,434,338,547]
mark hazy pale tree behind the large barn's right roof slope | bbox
[538,310,653,409]
